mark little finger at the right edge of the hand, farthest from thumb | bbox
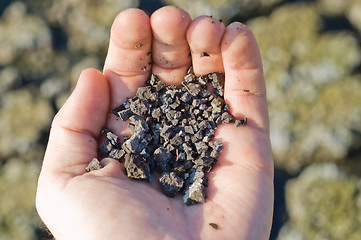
[221,22,268,133]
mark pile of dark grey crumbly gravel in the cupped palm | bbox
[94,68,247,205]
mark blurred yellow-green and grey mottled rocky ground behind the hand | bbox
[0,0,361,240]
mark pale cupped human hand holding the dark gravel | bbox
[36,6,273,240]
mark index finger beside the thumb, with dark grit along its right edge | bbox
[104,9,152,108]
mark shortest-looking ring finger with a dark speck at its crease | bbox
[187,16,224,75]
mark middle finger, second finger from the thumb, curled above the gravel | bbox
[150,6,191,85]
